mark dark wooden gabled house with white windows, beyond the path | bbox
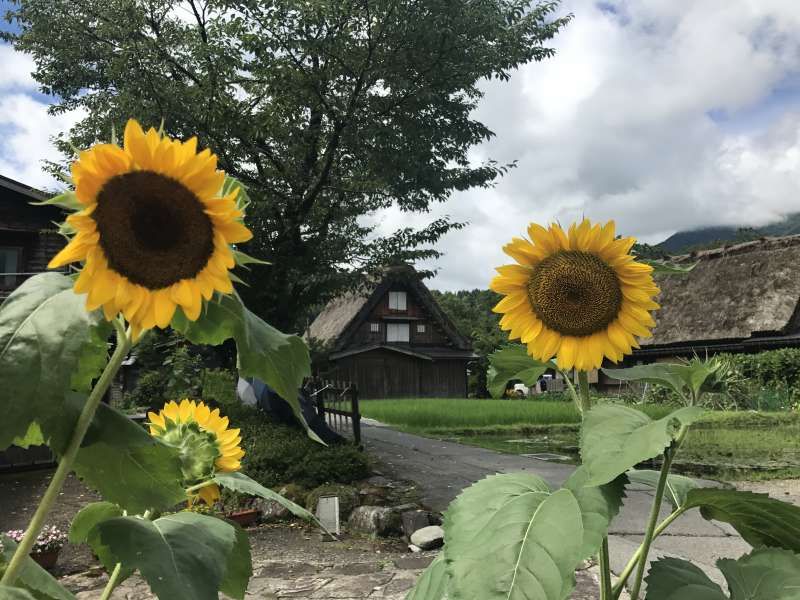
[306,266,476,398]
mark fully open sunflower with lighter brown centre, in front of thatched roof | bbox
[490,219,659,371]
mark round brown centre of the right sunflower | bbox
[528,251,622,337]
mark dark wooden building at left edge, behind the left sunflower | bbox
[0,175,66,301]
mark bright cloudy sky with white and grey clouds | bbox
[0,0,800,289]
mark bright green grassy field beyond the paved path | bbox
[361,398,800,480]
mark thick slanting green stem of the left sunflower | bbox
[0,320,130,586]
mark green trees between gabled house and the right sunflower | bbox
[432,289,508,398]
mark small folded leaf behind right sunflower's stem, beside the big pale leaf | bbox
[564,466,627,560]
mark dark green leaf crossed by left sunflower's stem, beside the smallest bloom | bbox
[42,393,186,513]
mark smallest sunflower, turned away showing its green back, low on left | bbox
[147,400,244,506]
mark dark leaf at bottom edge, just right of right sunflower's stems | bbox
[645,558,728,600]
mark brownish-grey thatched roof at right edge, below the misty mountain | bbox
[642,236,800,350]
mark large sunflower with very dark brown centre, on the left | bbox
[48,119,252,337]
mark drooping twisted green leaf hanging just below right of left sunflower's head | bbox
[172,295,322,443]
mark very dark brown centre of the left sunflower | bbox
[92,171,214,290]
